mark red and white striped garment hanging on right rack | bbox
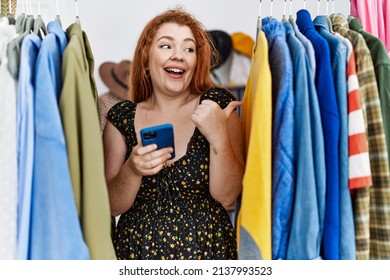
[346,34,372,190]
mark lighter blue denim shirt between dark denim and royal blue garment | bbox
[284,23,326,260]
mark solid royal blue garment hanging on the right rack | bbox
[296,10,340,260]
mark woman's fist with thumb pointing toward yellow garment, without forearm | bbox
[191,100,242,144]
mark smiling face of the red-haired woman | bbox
[149,23,196,95]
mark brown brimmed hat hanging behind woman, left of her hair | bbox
[99,60,131,99]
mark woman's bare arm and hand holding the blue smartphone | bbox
[103,121,172,216]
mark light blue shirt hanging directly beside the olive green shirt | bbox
[28,21,89,260]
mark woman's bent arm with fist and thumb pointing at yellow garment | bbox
[192,100,244,208]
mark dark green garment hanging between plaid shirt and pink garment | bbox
[349,18,390,171]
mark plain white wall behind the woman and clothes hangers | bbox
[17,0,350,93]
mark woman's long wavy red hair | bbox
[129,8,219,102]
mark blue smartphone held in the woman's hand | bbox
[140,123,175,159]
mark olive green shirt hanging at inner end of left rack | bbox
[59,23,116,259]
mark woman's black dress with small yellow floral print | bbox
[107,88,237,260]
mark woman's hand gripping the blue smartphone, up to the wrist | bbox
[126,143,173,176]
